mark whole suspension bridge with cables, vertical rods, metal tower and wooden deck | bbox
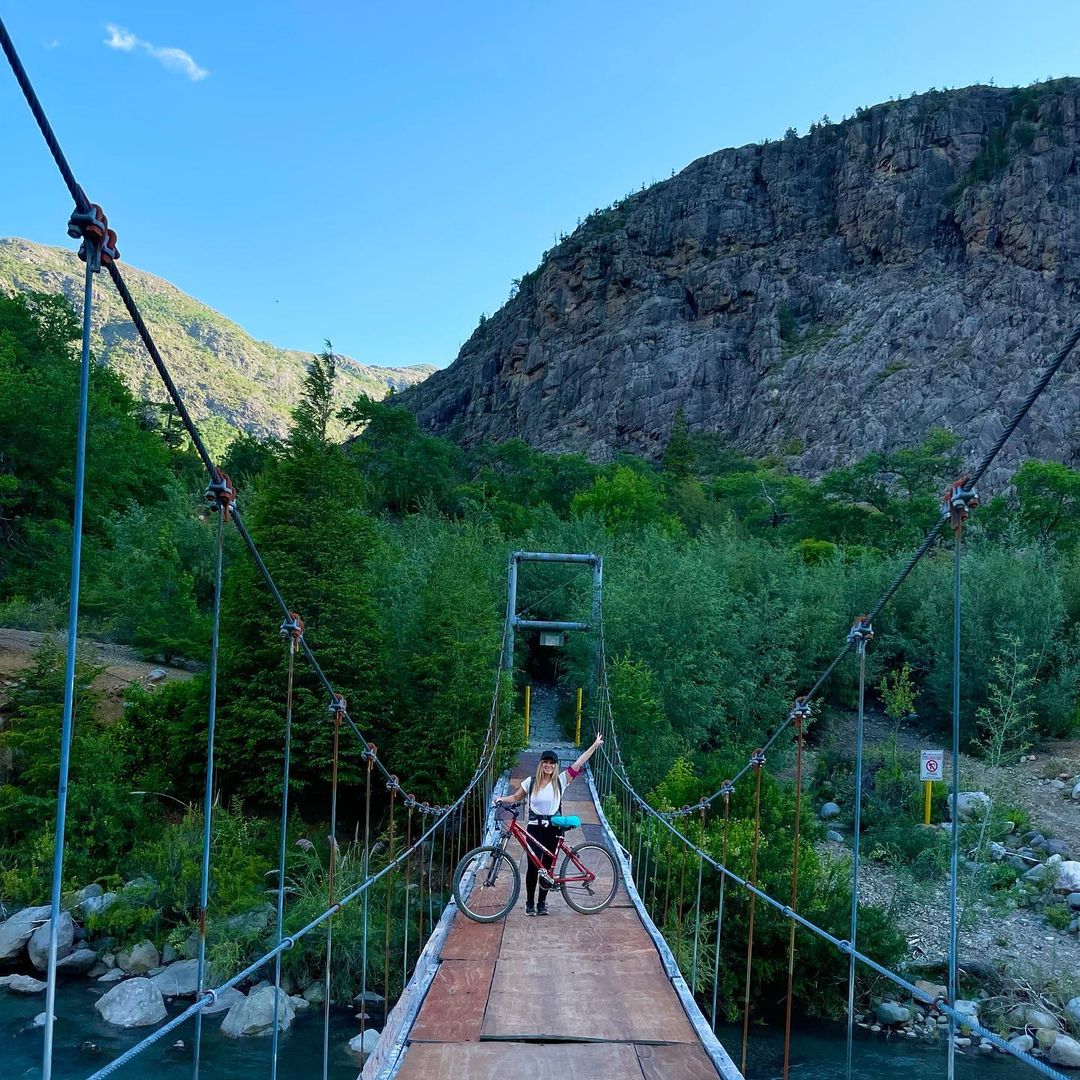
[0,22,1080,1080]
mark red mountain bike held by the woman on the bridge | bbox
[454,807,619,922]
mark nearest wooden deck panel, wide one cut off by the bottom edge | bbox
[397,1042,643,1080]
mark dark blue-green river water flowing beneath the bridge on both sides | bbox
[0,982,1037,1080]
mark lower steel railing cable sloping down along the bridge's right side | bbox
[599,718,1068,1080]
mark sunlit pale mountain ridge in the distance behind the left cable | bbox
[0,237,434,437]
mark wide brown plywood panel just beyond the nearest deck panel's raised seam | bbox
[481,958,697,1043]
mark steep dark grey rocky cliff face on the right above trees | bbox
[401,80,1080,486]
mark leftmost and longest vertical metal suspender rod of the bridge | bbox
[39,217,100,1080]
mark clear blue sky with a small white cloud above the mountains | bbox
[0,0,1080,365]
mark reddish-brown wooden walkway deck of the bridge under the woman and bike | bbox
[397,754,719,1080]
